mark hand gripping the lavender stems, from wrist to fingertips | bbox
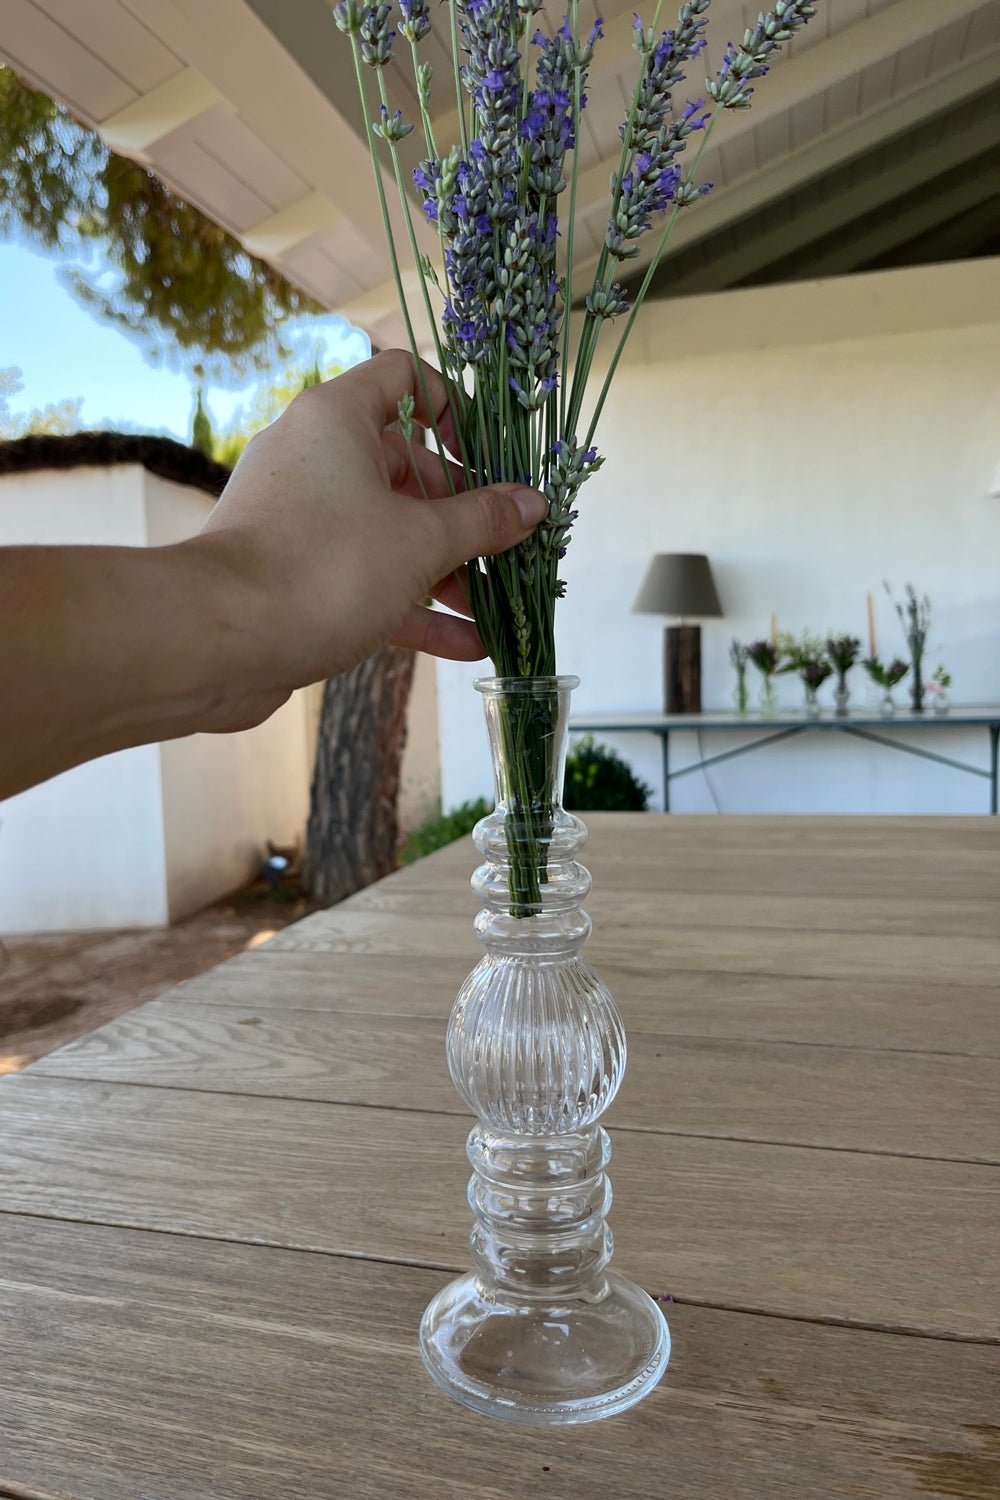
[192,351,546,692]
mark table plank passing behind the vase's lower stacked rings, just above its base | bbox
[0,1073,1000,1340]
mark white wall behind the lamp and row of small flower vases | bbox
[438,261,1000,813]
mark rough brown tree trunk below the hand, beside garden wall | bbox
[304,647,414,906]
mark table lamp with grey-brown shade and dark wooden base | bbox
[633,552,723,714]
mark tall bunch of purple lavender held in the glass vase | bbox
[333,0,816,909]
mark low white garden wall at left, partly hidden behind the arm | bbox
[0,464,309,935]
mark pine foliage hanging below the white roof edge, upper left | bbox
[0,66,324,374]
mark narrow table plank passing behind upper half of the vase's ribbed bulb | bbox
[164,945,1000,1058]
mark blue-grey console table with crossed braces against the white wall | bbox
[570,704,1000,818]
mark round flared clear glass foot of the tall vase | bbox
[420,1271,670,1427]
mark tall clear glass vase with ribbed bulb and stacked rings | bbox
[420,677,670,1427]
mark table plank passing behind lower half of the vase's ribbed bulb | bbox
[33,1001,1000,1163]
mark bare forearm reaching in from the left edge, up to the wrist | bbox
[0,539,262,797]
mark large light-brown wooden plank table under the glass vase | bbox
[0,815,1000,1500]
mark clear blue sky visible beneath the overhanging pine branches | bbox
[0,242,369,441]
